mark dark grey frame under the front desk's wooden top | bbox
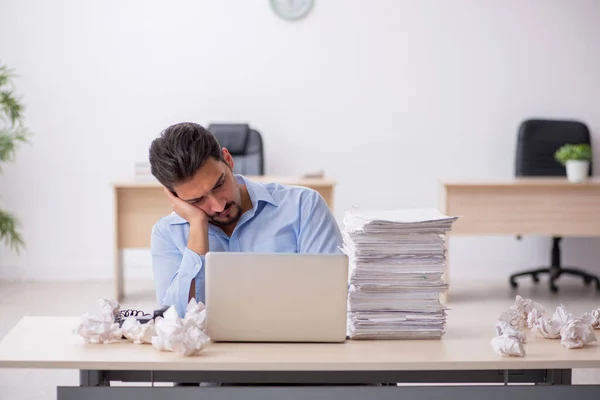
[57,369,600,400]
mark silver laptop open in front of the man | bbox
[205,252,348,342]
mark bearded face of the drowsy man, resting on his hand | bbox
[175,149,242,226]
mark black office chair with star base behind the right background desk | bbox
[510,119,600,293]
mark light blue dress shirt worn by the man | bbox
[150,175,342,317]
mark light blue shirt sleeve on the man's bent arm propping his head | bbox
[150,221,204,317]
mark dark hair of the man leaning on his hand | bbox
[149,122,222,190]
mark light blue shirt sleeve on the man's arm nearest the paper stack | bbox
[298,189,342,253]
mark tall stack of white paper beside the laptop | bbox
[343,208,457,339]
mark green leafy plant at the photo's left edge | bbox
[0,62,31,253]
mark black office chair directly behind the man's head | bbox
[207,124,265,175]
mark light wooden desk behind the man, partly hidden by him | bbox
[112,176,335,302]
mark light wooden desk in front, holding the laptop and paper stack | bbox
[0,312,600,400]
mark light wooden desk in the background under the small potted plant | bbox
[441,178,600,281]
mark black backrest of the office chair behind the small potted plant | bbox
[515,119,592,176]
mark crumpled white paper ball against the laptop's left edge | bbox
[152,298,210,357]
